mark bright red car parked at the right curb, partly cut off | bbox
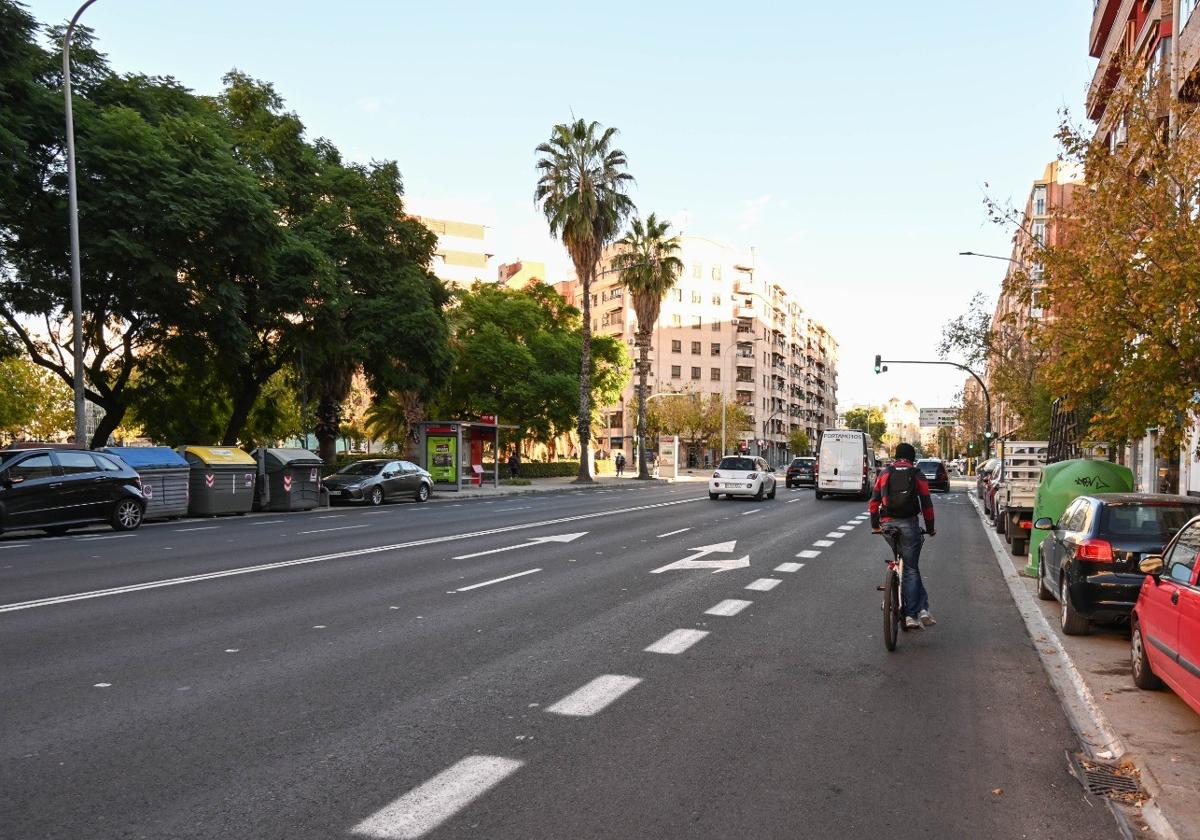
[1129,516,1200,714]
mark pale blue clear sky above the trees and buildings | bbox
[26,0,1094,407]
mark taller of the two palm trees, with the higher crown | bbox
[534,120,634,484]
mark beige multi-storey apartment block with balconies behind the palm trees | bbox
[566,236,838,467]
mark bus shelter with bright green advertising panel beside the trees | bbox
[418,418,516,492]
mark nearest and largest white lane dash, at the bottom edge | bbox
[350,756,524,840]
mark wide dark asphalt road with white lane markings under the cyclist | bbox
[0,484,1117,840]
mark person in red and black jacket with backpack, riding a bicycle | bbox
[868,443,937,630]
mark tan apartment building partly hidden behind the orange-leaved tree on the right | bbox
[984,161,1084,436]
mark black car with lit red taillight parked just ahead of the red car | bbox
[1033,493,1200,636]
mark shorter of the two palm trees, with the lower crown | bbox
[612,212,683,480]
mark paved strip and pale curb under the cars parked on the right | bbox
[967,485,1200,840]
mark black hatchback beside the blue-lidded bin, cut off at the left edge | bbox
[0,449,146,534]
